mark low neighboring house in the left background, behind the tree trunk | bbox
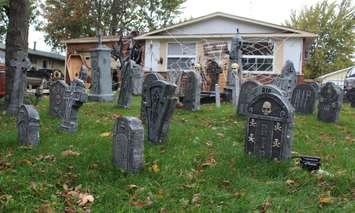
[0,44,65,72]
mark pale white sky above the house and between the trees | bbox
[28,0,330,51]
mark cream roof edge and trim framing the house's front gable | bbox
[135,12,316,40]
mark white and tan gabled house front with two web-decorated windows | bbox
[135,12,316,83]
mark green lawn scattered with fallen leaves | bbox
[0,98,355,212]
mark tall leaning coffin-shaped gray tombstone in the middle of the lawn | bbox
[142,75,177,144]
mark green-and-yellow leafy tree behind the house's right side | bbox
[286,0,355,78]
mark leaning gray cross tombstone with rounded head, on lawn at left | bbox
[60,79,87,133]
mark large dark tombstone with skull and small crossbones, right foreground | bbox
[245,85,293,160]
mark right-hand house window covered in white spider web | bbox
[241,39,274,72]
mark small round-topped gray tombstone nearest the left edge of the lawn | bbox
[17,105,40,145]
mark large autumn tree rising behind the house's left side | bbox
[38,0,186,49]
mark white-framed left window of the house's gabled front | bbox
[167,43,196,70]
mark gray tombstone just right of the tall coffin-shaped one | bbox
[183,71,202,111]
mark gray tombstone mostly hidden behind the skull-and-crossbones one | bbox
[238,80,261,115]
